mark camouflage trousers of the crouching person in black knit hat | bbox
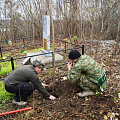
[78,74,99,91]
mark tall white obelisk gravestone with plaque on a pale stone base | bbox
[23,15,64,64]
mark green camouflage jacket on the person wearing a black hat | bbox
[68,55,108,91]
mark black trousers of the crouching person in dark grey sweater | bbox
[5,83,35,102]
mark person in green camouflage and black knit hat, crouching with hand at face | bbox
[67,50,108,97]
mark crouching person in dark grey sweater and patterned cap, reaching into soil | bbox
[4,60,56,105]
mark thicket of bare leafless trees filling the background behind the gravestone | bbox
[0,0,120,47]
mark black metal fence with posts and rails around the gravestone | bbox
[0,36,84,80]
